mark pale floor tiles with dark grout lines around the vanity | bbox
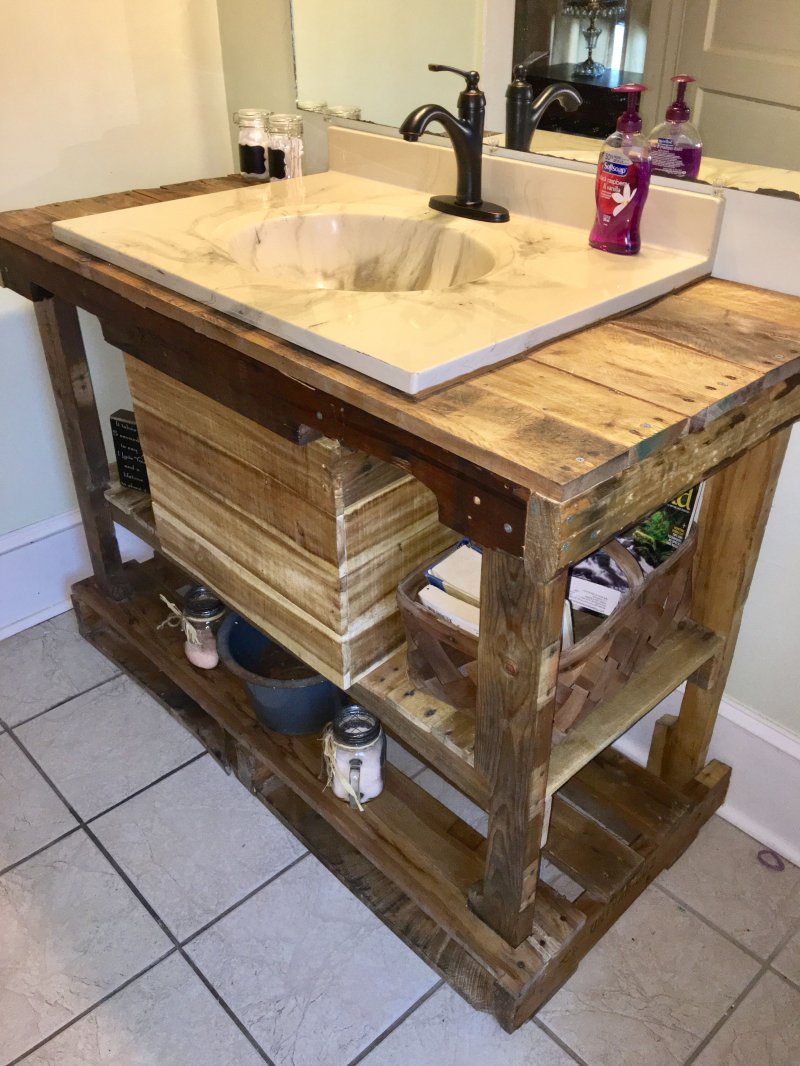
[0,615,800,1066]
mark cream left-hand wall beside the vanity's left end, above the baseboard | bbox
[0,0,230,535]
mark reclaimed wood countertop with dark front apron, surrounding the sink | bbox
[0,177,800,558]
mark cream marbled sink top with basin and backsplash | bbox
[53,130,721,394]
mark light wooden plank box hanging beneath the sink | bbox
[126,356,457,688]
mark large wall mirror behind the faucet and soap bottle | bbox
[291,0,800,198]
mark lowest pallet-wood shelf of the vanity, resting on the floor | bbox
[73,559,730,1030]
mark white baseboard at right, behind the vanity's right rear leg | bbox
[614,690,800,866]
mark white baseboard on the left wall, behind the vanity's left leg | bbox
[0,510,153,640]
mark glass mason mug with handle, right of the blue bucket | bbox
[322,704,386,810]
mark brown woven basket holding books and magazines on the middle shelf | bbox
[397,530,697,741]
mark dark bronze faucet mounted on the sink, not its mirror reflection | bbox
[400,63,509,222]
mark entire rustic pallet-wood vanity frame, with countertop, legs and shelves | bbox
[0,178,800,1030]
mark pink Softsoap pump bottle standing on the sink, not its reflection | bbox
[589,85,651,256]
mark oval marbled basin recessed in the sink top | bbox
[227,212,496,292]
